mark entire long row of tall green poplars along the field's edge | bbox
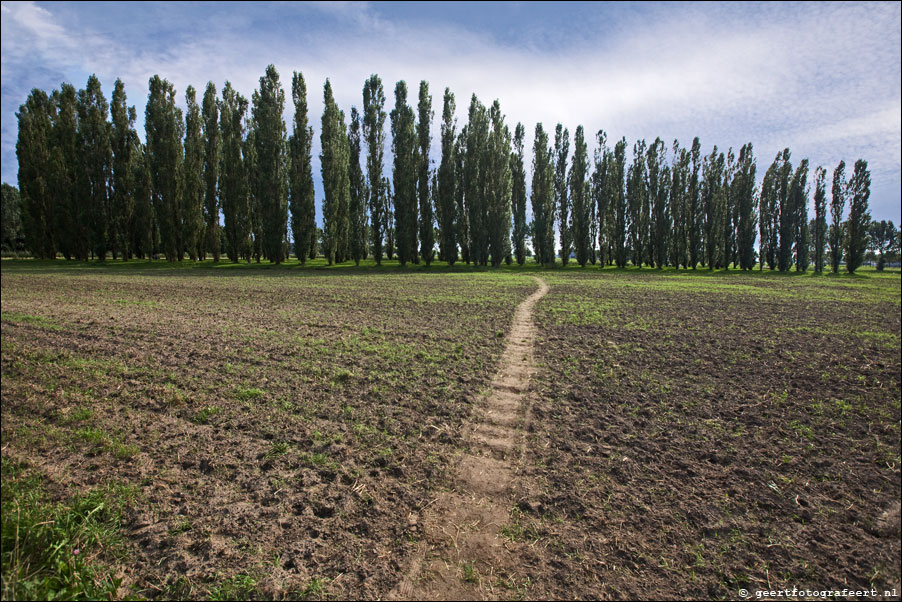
[16,65,870,271]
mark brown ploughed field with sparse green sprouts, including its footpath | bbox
[2,262,902,599]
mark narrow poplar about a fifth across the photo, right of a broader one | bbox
[182,86,205,261]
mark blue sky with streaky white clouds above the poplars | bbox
[0,2,902,224]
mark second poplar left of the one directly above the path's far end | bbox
[485,100,511,267]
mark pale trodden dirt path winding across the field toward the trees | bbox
[389,277,548,600]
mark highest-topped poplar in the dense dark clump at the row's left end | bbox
[76,75,112,261]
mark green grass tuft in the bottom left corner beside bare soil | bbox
[2,456,135,600]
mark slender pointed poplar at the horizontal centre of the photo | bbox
[435,88,457,266]
